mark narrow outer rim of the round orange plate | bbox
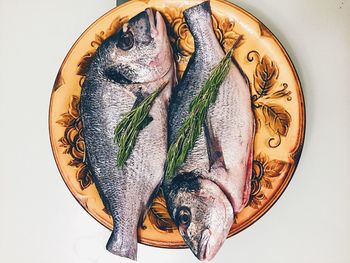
[48,0,306,249]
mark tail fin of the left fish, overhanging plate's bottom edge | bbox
[106,224,137,261]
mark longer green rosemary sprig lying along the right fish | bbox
[165,36,241,182]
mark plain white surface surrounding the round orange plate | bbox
[0,0,350,263]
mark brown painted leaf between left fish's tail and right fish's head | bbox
[148,191,176,232]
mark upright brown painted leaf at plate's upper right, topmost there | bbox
[254,56,278,96]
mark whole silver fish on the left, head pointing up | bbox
[80,9,176,260]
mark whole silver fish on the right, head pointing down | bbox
[163,1,254,260]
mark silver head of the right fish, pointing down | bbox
[167,172,234,260]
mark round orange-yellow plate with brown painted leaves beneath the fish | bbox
[49,0,305,248]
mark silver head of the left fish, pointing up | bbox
[98,8,174,84]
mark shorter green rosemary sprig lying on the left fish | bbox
[114,83,167,167]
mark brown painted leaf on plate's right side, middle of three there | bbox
[262,103,292,136]
